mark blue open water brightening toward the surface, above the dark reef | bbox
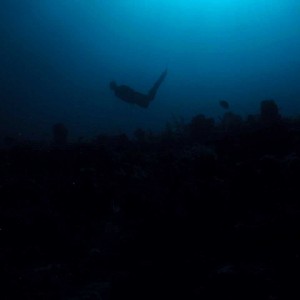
[0,0,300,139]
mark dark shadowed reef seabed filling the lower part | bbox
[0,102,300,300]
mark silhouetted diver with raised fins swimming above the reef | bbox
[109,69,168,108]
